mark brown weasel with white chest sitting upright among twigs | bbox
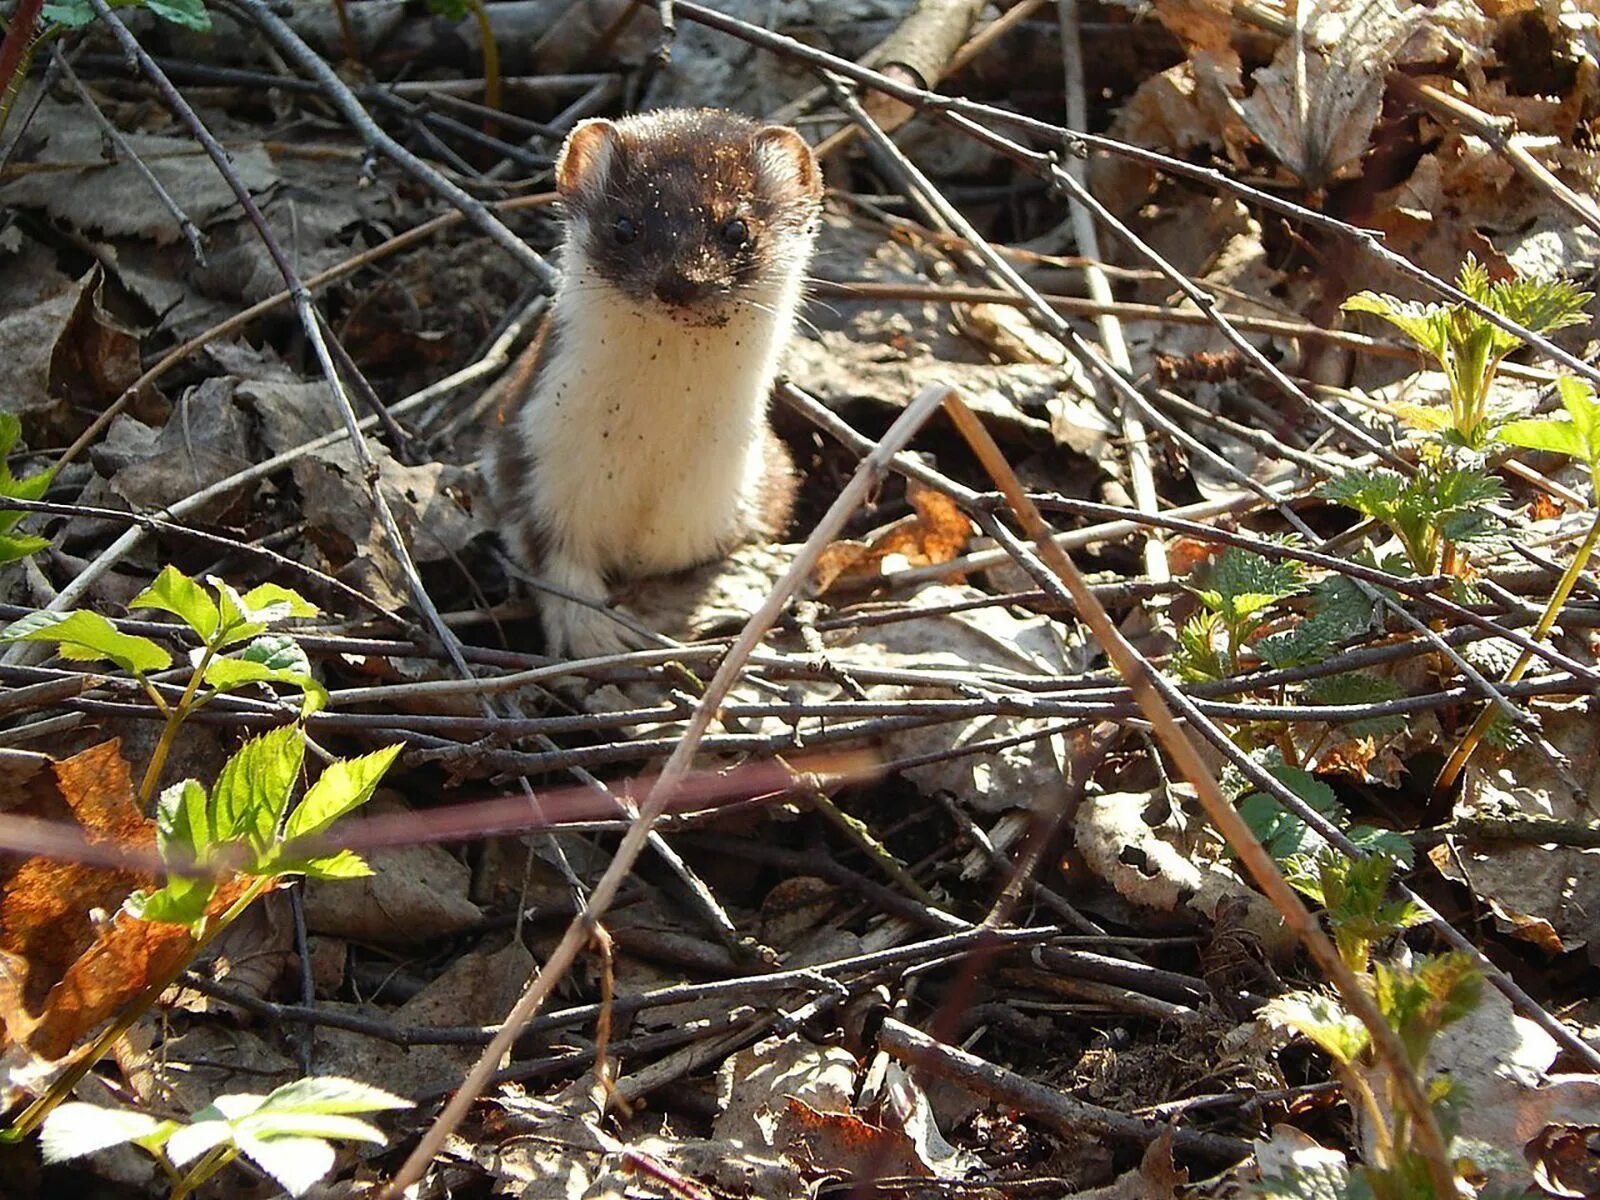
[486,109,822,658]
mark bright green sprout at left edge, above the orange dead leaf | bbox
[0,565,328,808]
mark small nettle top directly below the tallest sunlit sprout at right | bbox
[1317,464,1506,574]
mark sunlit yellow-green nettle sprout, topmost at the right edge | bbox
[1344,254,1590,451]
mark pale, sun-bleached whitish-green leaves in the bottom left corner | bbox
[40,1075,411,1200]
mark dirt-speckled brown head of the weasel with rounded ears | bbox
[555,109,822,325]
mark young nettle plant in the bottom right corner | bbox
[1261,850,1483,1200]
